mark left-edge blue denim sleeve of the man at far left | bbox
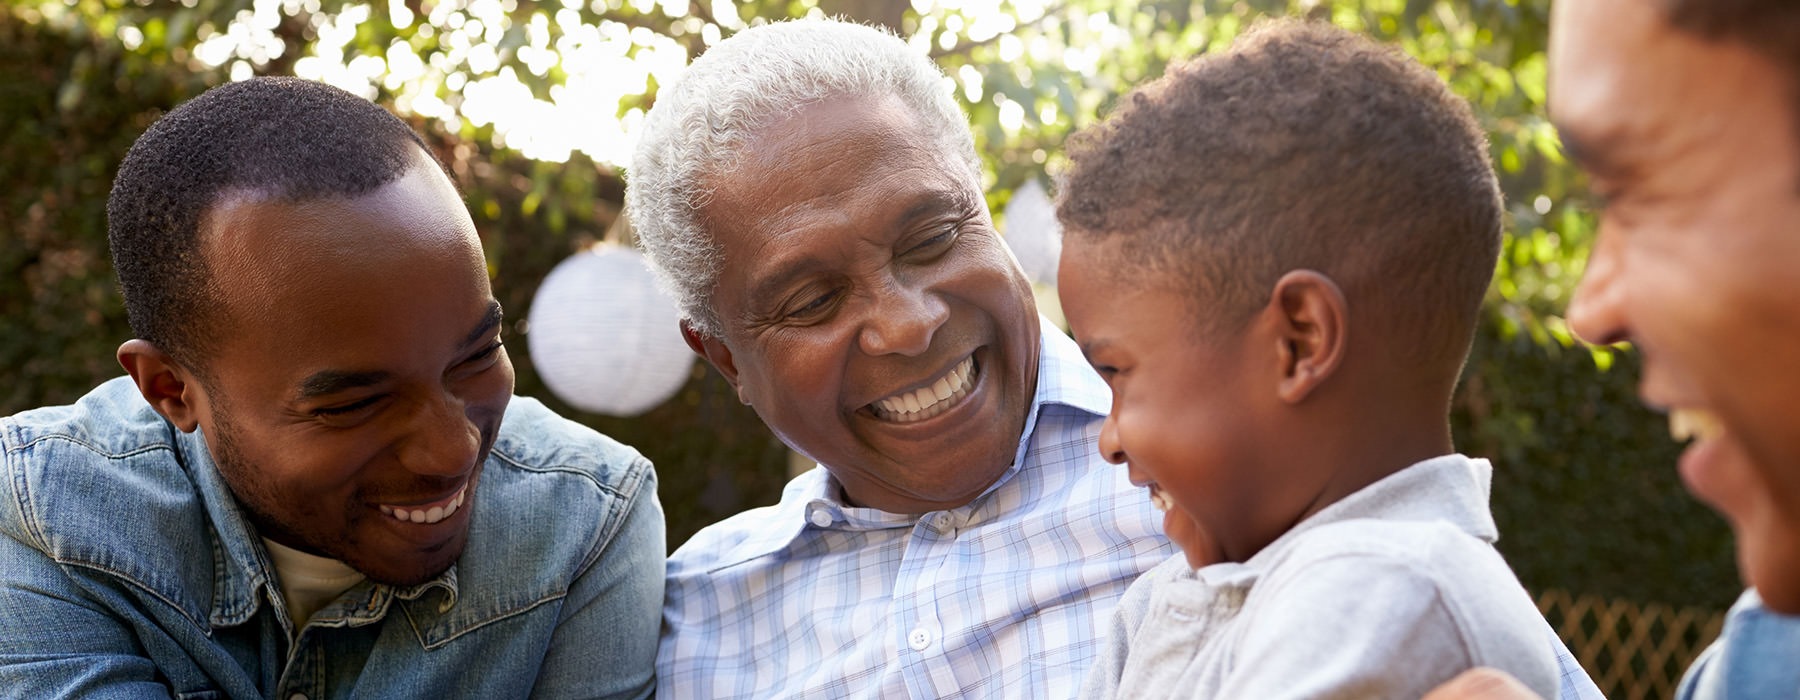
[0,525,169,698]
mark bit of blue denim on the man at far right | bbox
[1676,588,1800,700]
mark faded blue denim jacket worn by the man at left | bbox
[0,378,664,700]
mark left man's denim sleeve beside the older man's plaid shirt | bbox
[531,458,668,698]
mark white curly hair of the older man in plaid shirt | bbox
[625,20,981,337]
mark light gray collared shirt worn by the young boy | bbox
[1082,455,1591,700]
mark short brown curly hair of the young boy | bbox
[1057,20,1501,367]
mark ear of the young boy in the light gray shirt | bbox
[1269,270,1350,403]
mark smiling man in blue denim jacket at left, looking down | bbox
[0,79,664,698]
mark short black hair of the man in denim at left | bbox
[106,77,441,370]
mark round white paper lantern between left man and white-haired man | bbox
[527,243,695,416]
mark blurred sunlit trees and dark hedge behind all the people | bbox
[0,0,1741,608]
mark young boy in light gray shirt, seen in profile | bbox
[1057,22,1559,698]
